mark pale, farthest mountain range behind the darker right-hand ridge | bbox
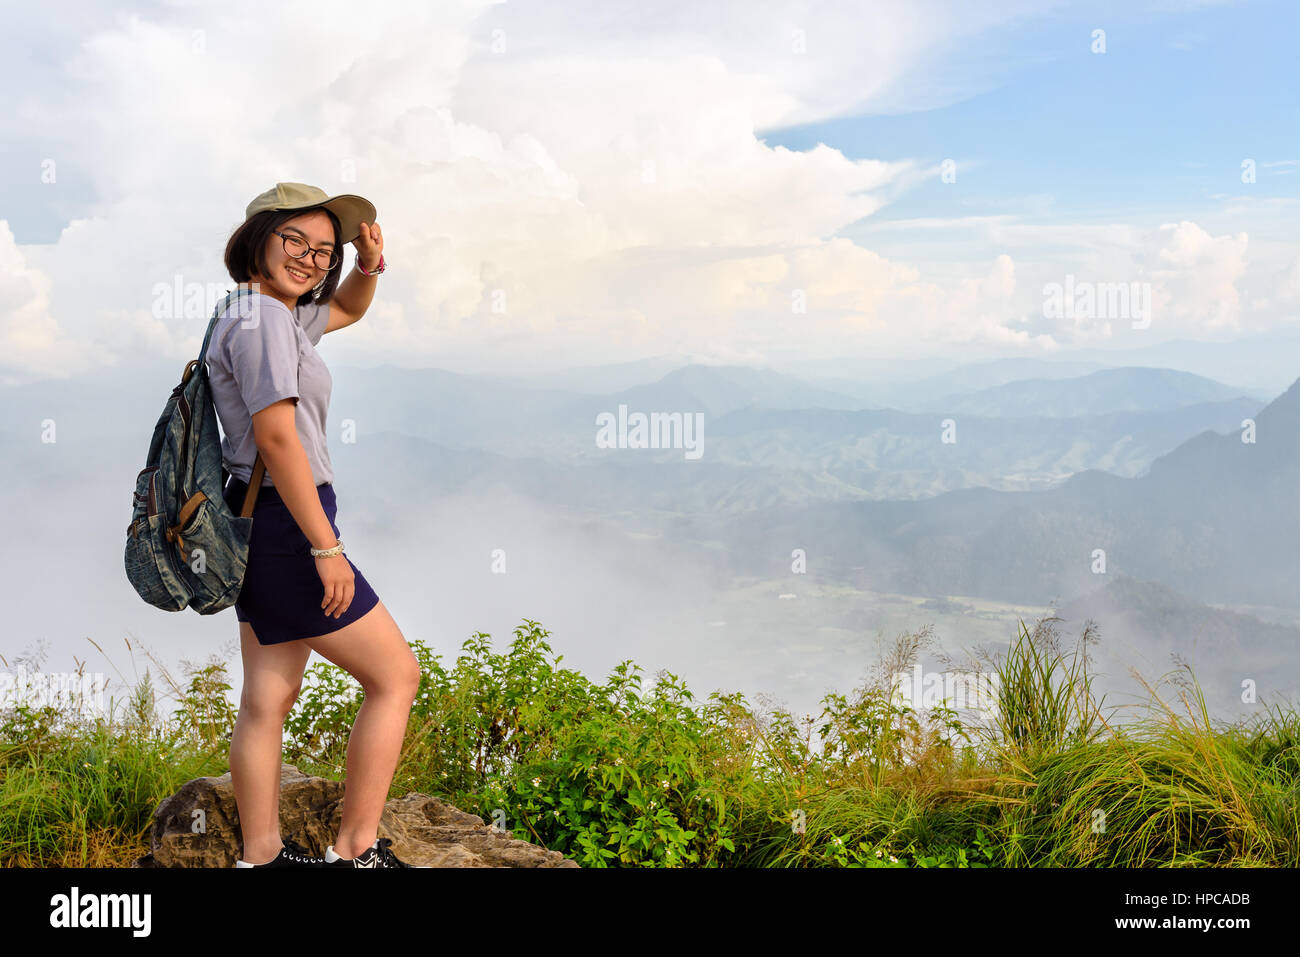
[312,365,1262,496]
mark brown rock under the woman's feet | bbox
[135,765,579,867]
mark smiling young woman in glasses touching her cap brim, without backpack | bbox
[208,183,420,867]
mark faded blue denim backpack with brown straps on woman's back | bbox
[126,286,267,615]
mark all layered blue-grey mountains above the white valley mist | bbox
[0,351,1300,607]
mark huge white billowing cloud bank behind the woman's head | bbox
[0,0,1294,374]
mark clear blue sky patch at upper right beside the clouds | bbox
[758,3,1300,227]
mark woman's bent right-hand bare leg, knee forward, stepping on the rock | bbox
[301,601,420,857]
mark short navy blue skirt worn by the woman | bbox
[225,476,380,645]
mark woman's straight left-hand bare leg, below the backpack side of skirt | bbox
[230,622,312,863]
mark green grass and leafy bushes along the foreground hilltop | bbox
[0,619,1300,867]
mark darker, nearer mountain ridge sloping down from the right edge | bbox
[710,371,1300,607]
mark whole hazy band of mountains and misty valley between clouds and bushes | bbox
[0,345,1300,709]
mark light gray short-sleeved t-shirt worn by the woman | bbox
[208,293,334,488]
